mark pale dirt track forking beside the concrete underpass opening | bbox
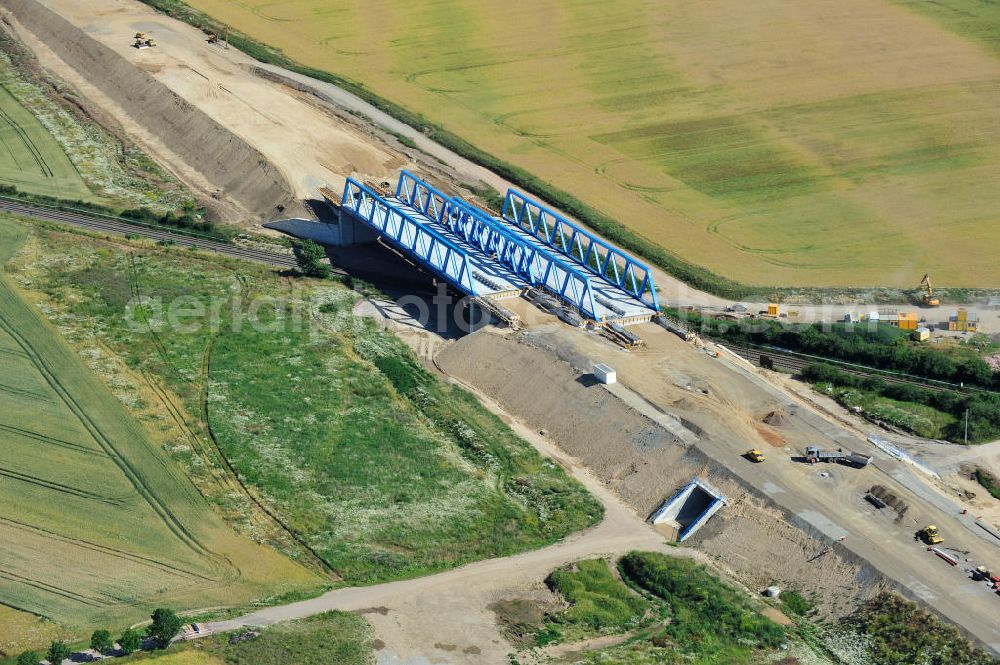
[189,422,707,665]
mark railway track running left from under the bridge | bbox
[0,198,296,268]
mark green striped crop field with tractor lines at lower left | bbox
[0,218,319,638]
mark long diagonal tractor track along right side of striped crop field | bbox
[0,282,232,577]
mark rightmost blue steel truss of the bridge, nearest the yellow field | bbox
[501,189,660,310]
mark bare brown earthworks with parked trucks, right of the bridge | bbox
[437,312,1000,652]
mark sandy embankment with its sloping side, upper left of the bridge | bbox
[0,0,408,218]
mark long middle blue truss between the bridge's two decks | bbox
[396,171,599,320]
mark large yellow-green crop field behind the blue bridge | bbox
[174,0,1000,287]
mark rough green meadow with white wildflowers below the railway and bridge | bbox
[7,222,601,583]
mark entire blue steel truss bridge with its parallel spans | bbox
[340,171,658,323]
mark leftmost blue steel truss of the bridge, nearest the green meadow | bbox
[340,178,477,297]
